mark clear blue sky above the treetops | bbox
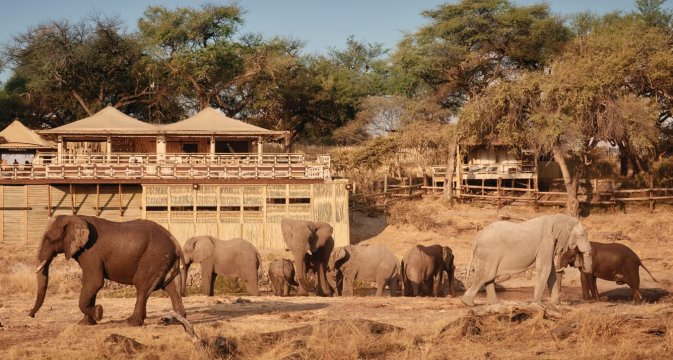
[0,0,673,80]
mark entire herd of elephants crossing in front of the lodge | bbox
[29,214,656,326]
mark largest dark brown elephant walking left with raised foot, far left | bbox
[29,215,186,326]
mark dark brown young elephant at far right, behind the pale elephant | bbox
[560,241,658,304]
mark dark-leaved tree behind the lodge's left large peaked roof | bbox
[4,17,168,126]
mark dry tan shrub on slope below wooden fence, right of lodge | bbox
[388,199,453,231]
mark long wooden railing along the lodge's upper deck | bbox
[0,153,330,180]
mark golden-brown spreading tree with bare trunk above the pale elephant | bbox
[461,19,673,216]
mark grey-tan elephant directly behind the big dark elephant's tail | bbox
[182,235,262,296]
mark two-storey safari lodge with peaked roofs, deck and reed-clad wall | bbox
[0,107,349,250]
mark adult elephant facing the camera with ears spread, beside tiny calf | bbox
[280,218,334,296]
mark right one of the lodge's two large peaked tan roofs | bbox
[161,107,284,138]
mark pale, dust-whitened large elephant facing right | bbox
[461,214,592,306]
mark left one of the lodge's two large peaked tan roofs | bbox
[41,106,160,135]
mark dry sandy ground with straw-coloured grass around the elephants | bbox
[0,200,673,359]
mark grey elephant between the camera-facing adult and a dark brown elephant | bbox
[327,244,399,296]
